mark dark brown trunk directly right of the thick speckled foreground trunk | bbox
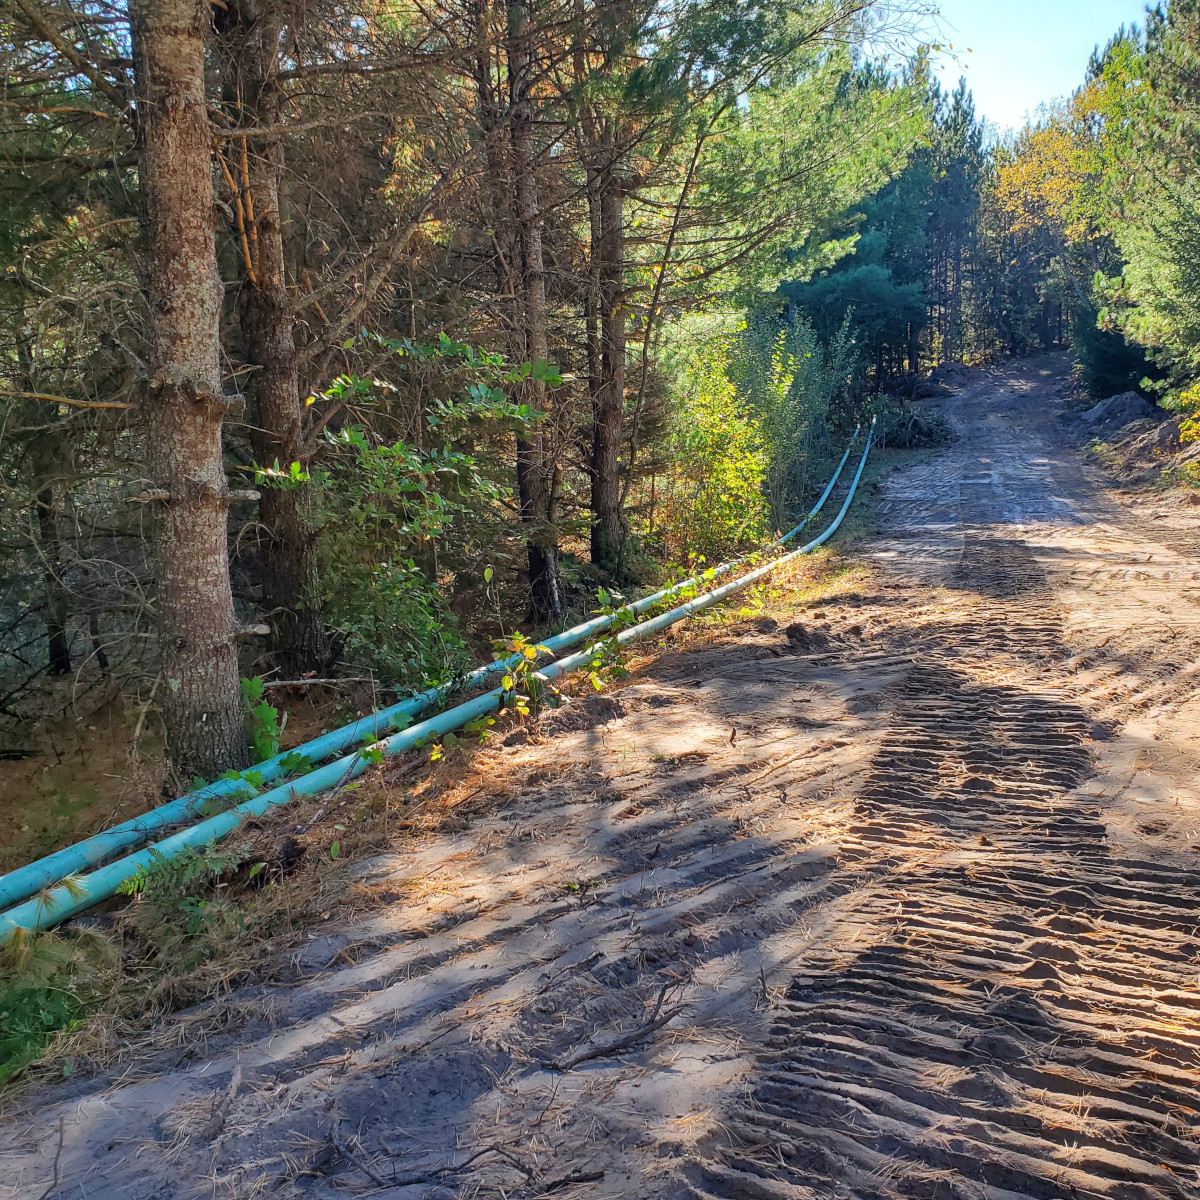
[220,0,331,676]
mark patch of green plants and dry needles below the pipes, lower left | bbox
[0,788,384,1084]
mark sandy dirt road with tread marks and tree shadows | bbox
[0,358,1200,1200]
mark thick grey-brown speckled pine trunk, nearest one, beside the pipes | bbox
[130,0,247,779]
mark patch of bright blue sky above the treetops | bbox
[938,0,1145,128]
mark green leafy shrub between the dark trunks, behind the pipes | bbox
[297,330,547,688]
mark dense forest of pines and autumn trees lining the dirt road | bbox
[0,0,1200,786]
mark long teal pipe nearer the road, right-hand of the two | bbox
[0,421,875,944]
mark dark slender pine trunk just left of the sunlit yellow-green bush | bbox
[590,166,628,575]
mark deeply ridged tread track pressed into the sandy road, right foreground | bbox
[679,453,1200,1200]
